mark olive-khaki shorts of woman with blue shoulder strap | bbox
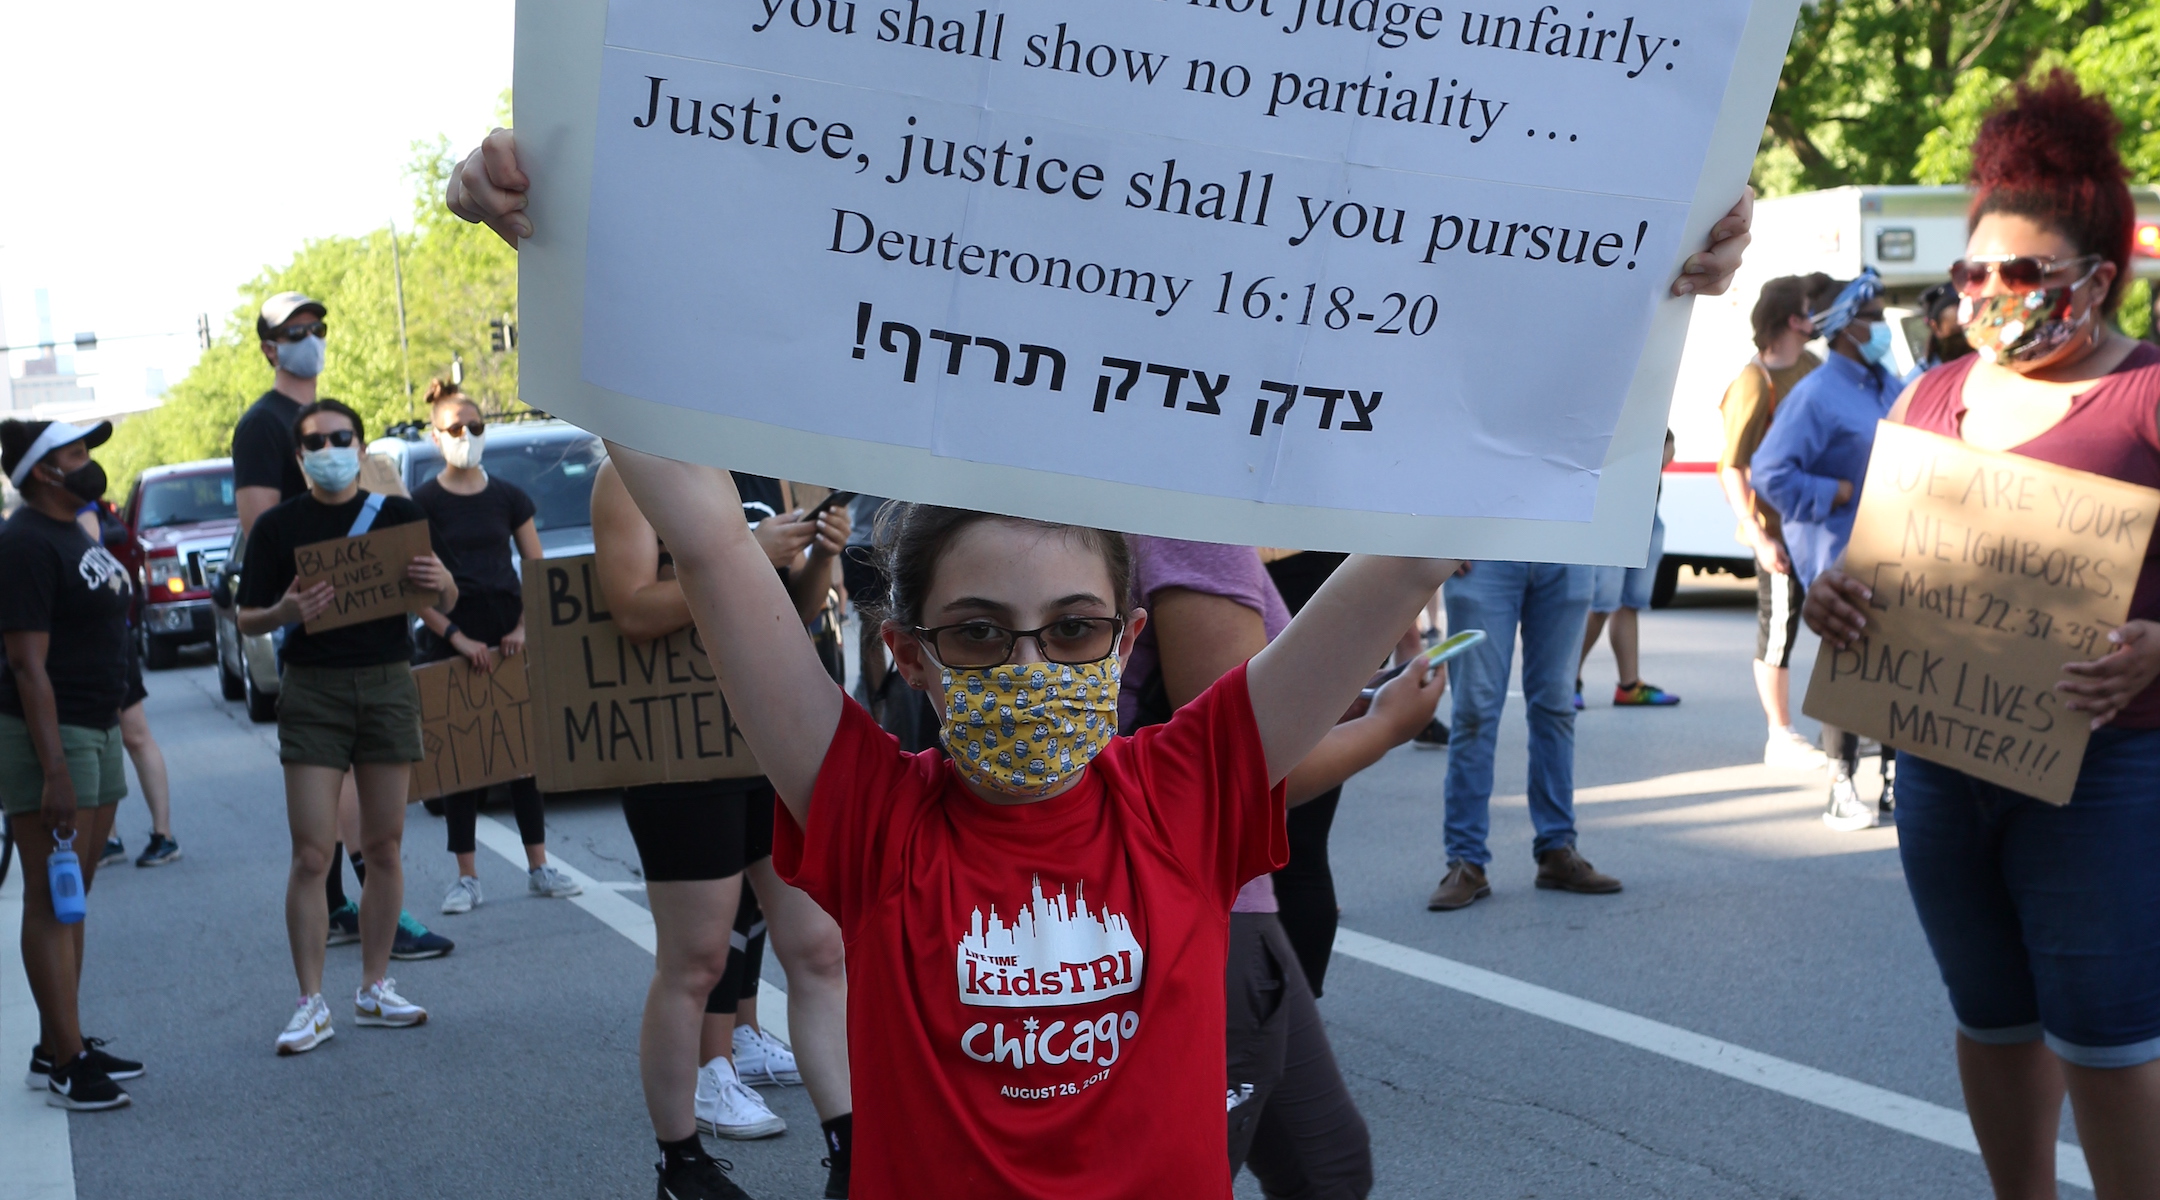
[276,663,426,771]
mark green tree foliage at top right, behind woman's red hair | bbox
[1754,0,2160,194]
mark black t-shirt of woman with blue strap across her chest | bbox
[238,488,458,667]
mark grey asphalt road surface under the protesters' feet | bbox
[0,574,2082,1200]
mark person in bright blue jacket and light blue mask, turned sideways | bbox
[1750,268,1901,831]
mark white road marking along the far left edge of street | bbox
[0,857,76,1200]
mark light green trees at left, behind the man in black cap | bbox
[99,138,518,488]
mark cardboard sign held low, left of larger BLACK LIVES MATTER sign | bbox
[410,650,534,801]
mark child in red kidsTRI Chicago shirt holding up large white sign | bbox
[447,129,1752,1200]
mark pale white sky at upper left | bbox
[0,0,514,401]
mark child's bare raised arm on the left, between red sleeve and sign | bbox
[607,442,851,827]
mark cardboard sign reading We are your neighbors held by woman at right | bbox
[1804,421,2160,805]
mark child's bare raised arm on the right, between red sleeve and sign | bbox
[1244,555,1462,783]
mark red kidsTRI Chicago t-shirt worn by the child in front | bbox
[773,667,1290,1200]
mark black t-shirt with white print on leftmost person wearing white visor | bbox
[0,505,127,729]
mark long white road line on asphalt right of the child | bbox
[1335,928,2093,1189]
